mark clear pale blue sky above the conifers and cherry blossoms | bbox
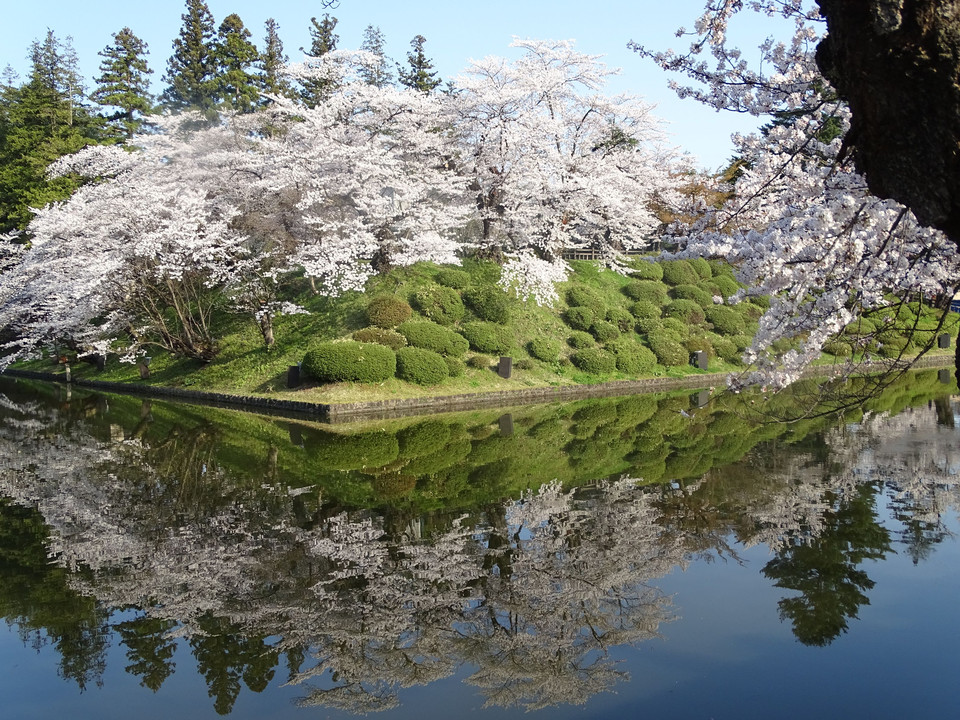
[0,0,777,169]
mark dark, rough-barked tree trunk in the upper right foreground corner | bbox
[817,0,960,378]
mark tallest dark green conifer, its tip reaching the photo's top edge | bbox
[160,0,217,116]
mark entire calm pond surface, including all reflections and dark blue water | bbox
[0,371,960,720]
